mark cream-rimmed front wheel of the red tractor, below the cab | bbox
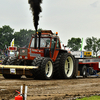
[33,57,53,80]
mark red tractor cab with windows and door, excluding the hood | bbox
[29,30,61,59]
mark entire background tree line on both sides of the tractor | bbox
[0,25,100,56]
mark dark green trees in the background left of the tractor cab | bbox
[0,25,41,50]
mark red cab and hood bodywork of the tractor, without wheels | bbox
[19,30,61,61]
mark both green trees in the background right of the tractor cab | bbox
[66,36,100,57]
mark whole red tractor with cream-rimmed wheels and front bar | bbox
[0,30,77,79]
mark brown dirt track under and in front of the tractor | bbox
[0,76,100,100]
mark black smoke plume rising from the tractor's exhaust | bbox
[28,0,42,31]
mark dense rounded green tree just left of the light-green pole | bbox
[67,38,81,51]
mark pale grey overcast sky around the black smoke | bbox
[0,0,100,48]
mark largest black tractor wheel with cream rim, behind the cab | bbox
[54,53,75,79]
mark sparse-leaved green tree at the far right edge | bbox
[84,37,100,57]
